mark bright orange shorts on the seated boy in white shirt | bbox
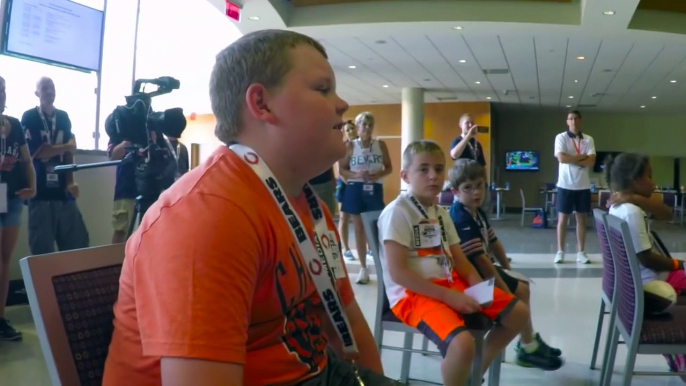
[392,273,517,356]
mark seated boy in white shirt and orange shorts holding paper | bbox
[378,140,529,386]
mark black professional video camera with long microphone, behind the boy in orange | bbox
[55,76,186,240]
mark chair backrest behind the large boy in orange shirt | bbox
[19,244,124,386]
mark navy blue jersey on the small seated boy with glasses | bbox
[448,201,498,262]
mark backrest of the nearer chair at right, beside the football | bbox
[606,214,643,338]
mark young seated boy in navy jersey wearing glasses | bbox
[448,159,563,371]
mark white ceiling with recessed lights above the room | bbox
[208,0,686,112]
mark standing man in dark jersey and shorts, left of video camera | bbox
[21,77,89,255]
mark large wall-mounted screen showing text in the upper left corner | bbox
[2,0,104,71]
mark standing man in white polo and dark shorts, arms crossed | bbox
[555,110,595,264]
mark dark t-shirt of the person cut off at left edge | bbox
[0,117,28,200]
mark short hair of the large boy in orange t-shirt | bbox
[210,29,328,143]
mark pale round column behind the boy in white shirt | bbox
[393,87,424,190]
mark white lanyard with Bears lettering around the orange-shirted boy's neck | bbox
[229,144,364,386]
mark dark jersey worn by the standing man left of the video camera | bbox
[21,107,72,200]
